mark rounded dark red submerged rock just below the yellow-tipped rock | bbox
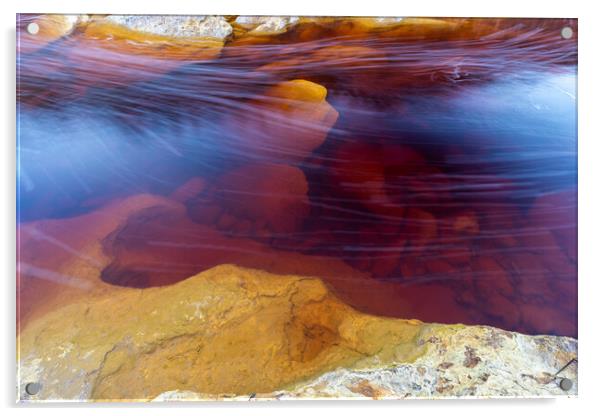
[216,164,310,233]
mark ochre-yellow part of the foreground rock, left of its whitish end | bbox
[19,265,422,400]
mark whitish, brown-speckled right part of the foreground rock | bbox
[275,326,577,400]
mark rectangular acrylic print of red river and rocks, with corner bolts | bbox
[17,15,577,401]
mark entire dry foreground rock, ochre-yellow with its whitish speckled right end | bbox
[19,265,577,400]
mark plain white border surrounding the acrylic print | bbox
[0,0,602,416]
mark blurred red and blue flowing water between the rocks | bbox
[17,16,577,336]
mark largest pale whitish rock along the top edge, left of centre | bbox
[104,15,232,40]
